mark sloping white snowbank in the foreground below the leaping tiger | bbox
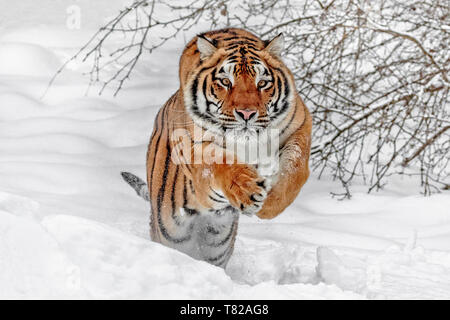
[0,193,358,299]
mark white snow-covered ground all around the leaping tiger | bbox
[0,0,450,299]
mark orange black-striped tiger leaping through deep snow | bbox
[122,28,312,268]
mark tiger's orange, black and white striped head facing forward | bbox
[180,29,295,135]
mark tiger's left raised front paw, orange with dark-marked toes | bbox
[216,165,268,215]
